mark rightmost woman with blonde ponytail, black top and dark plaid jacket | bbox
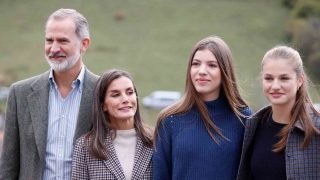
[238,46,320,180]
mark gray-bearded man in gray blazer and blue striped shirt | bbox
[0,9,98,180]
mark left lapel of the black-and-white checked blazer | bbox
[104,135,125,179]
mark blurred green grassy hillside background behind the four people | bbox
[0,0,320,131]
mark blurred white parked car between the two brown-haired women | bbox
[142,91,181,109]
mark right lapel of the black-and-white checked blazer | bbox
[132,136,153,180]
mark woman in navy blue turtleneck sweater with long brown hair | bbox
[153,36,251,180]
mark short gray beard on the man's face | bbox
[46,51,81,72]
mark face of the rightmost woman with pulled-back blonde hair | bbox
[262,59,303,106]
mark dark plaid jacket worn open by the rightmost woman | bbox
[237,106,320,180]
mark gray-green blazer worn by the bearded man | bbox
[0,69,98,180]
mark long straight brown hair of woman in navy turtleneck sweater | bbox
[154,36,248,144]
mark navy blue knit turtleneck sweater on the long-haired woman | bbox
[153,97,252,180]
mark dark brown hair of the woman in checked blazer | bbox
[85,69,153,160]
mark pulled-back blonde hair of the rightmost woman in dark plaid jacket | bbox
[261,46,320,152]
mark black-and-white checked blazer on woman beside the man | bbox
[71,133,153,180]
